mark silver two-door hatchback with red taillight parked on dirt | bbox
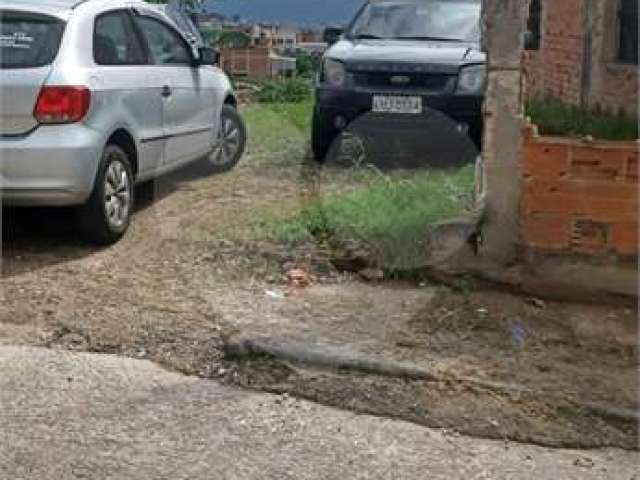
[0,0,246,244]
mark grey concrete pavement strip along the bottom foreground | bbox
[0,348,639,480]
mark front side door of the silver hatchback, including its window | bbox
[135,14,215,163]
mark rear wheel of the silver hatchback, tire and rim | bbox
[78,145,134,245]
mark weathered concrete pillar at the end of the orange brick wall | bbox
[480,0,529,265]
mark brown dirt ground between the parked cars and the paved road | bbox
[0,104,638,448]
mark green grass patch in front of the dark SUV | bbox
[262,166,474,244]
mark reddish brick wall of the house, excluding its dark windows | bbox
[524,0,639,116]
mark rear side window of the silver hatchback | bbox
[93,10,148,65]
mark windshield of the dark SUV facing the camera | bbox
[347,0,481,42]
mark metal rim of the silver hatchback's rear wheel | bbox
[104,160,131,229]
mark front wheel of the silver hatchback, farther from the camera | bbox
[207,105,247,173]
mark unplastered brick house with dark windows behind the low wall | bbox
[525,0,639,116]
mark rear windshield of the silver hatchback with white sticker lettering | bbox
[0,11,64,69]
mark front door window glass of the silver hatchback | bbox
[136,16,192,65]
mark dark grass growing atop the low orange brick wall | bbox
[526,98,638,140]
